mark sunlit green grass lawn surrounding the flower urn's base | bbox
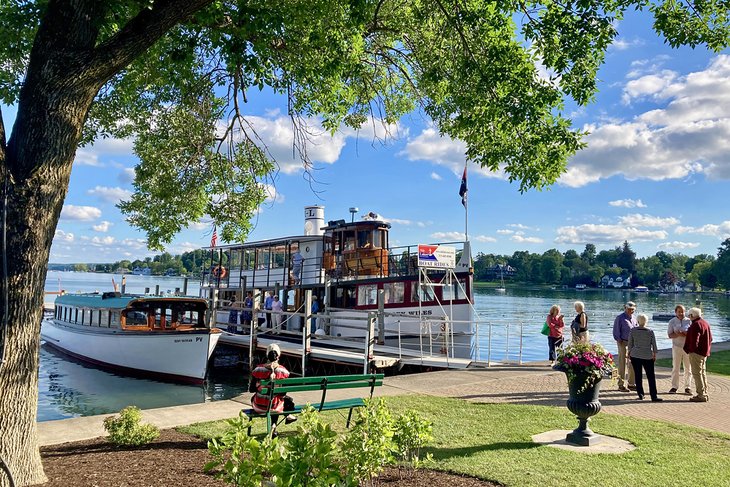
[180,396,730,487]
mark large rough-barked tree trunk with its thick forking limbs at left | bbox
[0,0,216,487]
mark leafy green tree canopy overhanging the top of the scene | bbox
[0,0,728,249]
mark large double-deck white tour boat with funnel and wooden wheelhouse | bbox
[201,206,473,358]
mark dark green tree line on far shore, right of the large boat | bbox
[474,238,730,290]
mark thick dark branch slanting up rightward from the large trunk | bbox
[91,0,213,83]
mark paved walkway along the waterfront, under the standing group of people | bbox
[38,342,730,446]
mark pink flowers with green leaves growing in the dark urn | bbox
[553,343,616,393]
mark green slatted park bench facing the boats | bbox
[243,374,383,436]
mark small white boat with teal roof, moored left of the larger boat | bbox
[41,292,221,383]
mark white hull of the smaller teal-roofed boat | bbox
[41,320,220,383]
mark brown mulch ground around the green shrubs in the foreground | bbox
[41,430,497,487]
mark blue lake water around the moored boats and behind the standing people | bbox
[38,271,730,421]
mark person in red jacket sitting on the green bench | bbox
[249,343,297,437]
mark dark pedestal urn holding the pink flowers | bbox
[565,374,601,446]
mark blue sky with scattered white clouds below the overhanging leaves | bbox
[3,9,730,263]
